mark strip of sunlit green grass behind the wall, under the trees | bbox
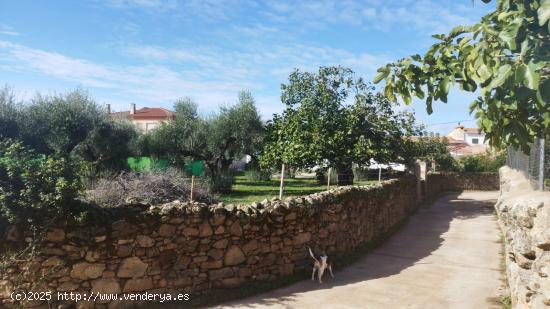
[219,176,378,204]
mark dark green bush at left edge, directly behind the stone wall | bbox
[0,139,81,223]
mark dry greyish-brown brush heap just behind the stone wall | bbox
[84,168,213,207]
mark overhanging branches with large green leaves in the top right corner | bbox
[374,0,550,149]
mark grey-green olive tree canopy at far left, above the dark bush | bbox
[0,87,137,169]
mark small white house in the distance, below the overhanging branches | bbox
[447,123,489,157]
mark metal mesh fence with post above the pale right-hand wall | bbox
[506,139,550,191]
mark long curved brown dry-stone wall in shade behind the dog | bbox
[0,175,500,308]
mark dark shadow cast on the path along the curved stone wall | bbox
[224,192,500,308]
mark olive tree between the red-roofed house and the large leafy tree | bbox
[142,91,263,173]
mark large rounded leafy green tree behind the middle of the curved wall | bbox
[261,67,414,184]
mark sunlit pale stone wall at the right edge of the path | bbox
[495,167,550,308]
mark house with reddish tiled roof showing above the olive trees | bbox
[107,103,176,133]
